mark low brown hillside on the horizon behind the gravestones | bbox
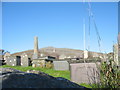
[12,47,103,58]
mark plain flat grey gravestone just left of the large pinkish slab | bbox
[53,61,69,70]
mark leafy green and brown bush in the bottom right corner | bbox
[100,60,120,88]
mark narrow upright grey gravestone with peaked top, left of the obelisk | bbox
[21,53,30,67]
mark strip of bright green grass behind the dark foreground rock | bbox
[0,65,92,88]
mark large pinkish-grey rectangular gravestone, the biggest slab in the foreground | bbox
[70,63,99,84]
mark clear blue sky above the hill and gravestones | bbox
[2,2,118,53]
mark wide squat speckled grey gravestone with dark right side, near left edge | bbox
[6,56,21,66]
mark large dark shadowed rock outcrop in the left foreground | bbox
[0,68,85,89]
